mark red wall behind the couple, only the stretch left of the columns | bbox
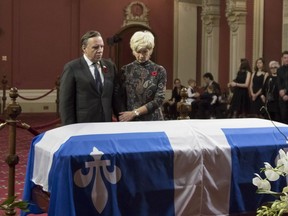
[0,0,174,89]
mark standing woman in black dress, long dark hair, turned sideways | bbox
[227,58,251,118]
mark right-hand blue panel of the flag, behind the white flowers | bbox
[223,127,288,213]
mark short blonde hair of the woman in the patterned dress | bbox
[130,31,155,52]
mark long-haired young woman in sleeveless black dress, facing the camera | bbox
[249,58,268,118]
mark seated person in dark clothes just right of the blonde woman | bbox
[163,78,185,119]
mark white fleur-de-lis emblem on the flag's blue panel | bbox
[74,147,121,213]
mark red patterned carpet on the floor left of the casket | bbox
[0,113,59,216]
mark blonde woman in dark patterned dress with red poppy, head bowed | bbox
[119,31,167,121]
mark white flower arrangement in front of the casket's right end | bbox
[252,149,288,216]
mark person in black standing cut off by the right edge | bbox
[277,50,288,124]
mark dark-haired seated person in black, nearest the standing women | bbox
[192,73,221,119]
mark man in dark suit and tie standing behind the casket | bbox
[59,31,121,125]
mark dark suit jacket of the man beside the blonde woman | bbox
[59,56,122,125]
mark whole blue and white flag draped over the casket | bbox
[21,119,288,216]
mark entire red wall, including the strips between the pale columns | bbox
[0,0,283,89]
